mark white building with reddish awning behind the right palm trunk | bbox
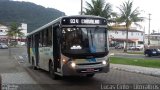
[109,29,144,47]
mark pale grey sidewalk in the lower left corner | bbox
[0,53,36,84]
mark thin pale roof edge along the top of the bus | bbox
[27,15,106,36]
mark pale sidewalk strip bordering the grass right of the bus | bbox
[110,64,160,77]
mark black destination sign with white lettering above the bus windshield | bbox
[62,18,107,25]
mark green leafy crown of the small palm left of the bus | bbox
[7,23,24,45]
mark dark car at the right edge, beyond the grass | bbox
[144,49,160,57]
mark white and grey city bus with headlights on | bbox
[27,15,109,79]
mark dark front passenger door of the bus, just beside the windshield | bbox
[53,26,61,71]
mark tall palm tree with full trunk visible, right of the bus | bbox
[117,1,144,52]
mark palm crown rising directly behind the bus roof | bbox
[84,0,116,20]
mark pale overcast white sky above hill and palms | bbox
[15,0,160,33]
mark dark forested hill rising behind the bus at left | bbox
[0,0,65,32]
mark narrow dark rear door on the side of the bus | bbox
[34,34,39,66]
